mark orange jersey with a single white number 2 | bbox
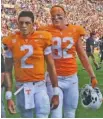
[3,31,52,82]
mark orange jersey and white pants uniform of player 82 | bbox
[40,25,85,118]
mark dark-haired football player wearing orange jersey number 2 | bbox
[3,11,59,118]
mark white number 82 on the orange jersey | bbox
[52,37,74,59]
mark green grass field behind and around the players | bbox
[6,55,103,118]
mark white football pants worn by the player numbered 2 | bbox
[16,81,50,118]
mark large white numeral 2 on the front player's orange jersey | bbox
[20,45,34,68]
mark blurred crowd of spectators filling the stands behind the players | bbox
[1,0,103,36]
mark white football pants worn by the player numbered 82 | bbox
[45,72,79,118]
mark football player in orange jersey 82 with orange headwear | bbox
[40,5,97,118]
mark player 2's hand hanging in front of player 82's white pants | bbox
[50,95,59,109]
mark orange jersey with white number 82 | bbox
[40,25,85,76]
